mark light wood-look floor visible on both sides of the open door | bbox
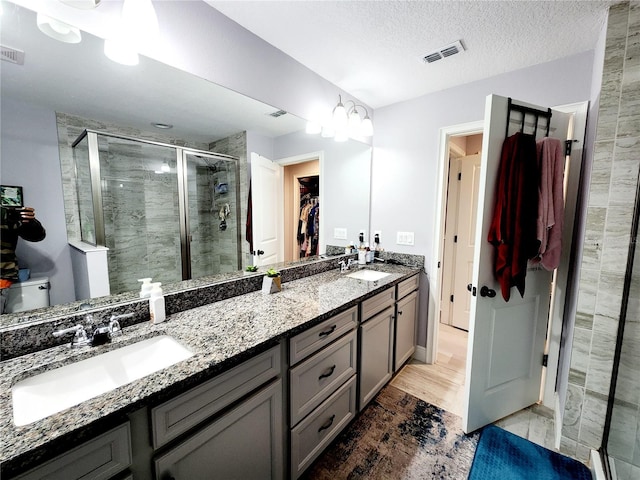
[391,323,557,451]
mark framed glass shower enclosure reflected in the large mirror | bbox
[73,130,241,294]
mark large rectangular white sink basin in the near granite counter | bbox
[11,335,193,426]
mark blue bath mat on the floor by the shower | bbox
[469,425,591,480]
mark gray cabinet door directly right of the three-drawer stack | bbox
[358,307,394,410]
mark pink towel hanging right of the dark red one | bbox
[536,138,565,270]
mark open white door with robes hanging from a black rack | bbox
[462,95,569,432]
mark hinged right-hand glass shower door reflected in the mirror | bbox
[184,150,241,278]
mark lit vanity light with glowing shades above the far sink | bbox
[306,95,373,142]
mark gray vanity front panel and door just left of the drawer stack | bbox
[151,346,284,480]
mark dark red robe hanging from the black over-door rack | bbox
[487,132,539,302]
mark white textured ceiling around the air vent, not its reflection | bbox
[205,0,616,108]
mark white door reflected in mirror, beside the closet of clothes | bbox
[251,152,284,265]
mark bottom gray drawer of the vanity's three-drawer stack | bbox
[291,375,356,478]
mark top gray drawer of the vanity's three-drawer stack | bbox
[289,307,358,365]
